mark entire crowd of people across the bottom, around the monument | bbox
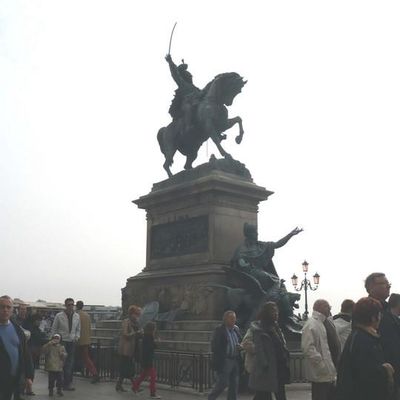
[0,273,400,400]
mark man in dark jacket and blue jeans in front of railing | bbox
[208,311,242,400]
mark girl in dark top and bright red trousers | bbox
[132,322,161,399]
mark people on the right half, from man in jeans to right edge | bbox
[208,273,400,400]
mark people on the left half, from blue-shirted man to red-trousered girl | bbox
[0,296,161,400]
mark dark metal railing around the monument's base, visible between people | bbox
[83,344,306,392]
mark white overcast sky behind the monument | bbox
[0,0,400,312]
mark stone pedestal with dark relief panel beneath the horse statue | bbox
[122,159,272,320]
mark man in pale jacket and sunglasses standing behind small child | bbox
[51,298,81,390]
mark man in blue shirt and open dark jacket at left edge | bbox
[0,296,33,400]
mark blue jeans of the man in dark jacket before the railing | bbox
[208,358,239,400]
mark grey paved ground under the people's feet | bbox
[29,371,311,400]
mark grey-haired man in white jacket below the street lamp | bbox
[301,299,336,400]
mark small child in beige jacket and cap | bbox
[42,333,67,396]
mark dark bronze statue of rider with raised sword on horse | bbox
[157,29,247,177]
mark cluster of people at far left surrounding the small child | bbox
[0,295,99,400]
